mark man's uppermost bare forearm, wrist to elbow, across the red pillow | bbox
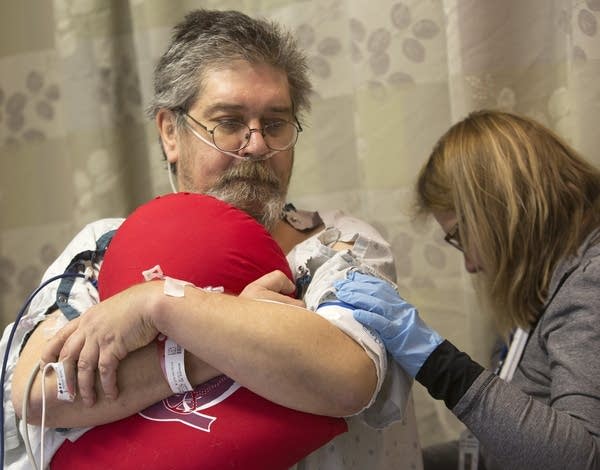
[151,287,377,416]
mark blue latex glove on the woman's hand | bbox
[335,271,444,377]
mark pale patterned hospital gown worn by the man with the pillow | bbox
[0,211,422,470]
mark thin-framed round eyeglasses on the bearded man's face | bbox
[185,113,302,152]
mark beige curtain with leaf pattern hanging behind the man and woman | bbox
[0,0,600,445]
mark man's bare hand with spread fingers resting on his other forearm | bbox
[42,282,164,406]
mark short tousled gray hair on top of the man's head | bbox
[147,10,312,123]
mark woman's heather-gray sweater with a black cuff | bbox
[417,231,600,470]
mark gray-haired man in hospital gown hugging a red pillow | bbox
[8,10,420,470]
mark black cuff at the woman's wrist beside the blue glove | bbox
[415,340,484,409]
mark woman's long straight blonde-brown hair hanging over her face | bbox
[416,111,600,333]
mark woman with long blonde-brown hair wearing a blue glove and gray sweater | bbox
[337,111,600,470]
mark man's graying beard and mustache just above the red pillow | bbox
[206,162,287,232]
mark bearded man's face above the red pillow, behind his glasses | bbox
[163,61,294,228]
